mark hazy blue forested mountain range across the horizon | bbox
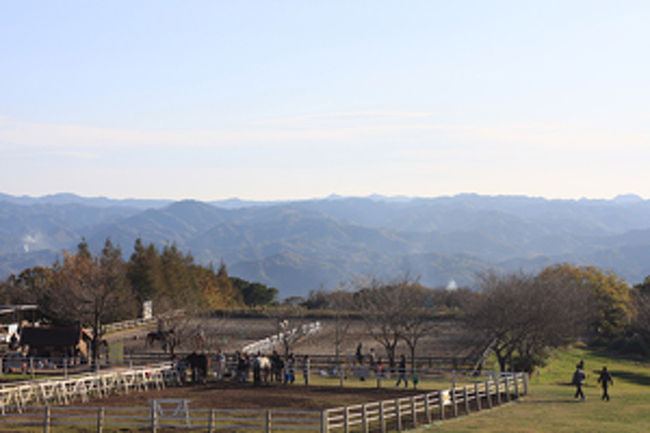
[0,194,650,297]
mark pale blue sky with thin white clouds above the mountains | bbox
[0,0,650,200]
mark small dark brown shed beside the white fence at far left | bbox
[20,326,93,362]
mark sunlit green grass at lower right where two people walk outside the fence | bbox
[417,347,650,433]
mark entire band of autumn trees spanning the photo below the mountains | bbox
[0,239,650,371]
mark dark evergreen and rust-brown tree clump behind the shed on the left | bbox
[0,238,278,362]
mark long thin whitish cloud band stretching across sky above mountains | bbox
[0,115,650,159]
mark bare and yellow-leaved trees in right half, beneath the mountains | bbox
[292,264,650,372]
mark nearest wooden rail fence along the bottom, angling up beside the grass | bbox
[0,373,528,433]
